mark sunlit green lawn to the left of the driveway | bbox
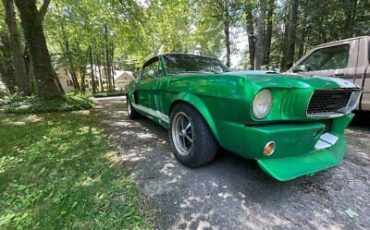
[0,111,152,229]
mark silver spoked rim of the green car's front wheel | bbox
[171,112,193,156]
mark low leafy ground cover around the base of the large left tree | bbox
[2,95,94,114]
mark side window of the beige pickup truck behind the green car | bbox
[298,45,349,71]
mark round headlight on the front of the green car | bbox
[253,89,272,118]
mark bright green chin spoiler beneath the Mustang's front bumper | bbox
[257,136,347,181]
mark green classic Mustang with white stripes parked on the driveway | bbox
[126,54,361,181]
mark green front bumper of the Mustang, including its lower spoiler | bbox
[221,114,353,181]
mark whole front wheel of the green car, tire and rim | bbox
[169,103,218,168]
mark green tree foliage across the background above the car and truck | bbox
[0,0,370,80]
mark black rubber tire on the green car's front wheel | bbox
[168,103,219,168]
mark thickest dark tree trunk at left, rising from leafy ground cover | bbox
[15,0,64,98]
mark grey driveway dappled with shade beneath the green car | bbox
[96,97,370,230]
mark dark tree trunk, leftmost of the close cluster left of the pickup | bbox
[245,1,256,69]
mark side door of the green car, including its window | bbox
[134,57,160,113]
